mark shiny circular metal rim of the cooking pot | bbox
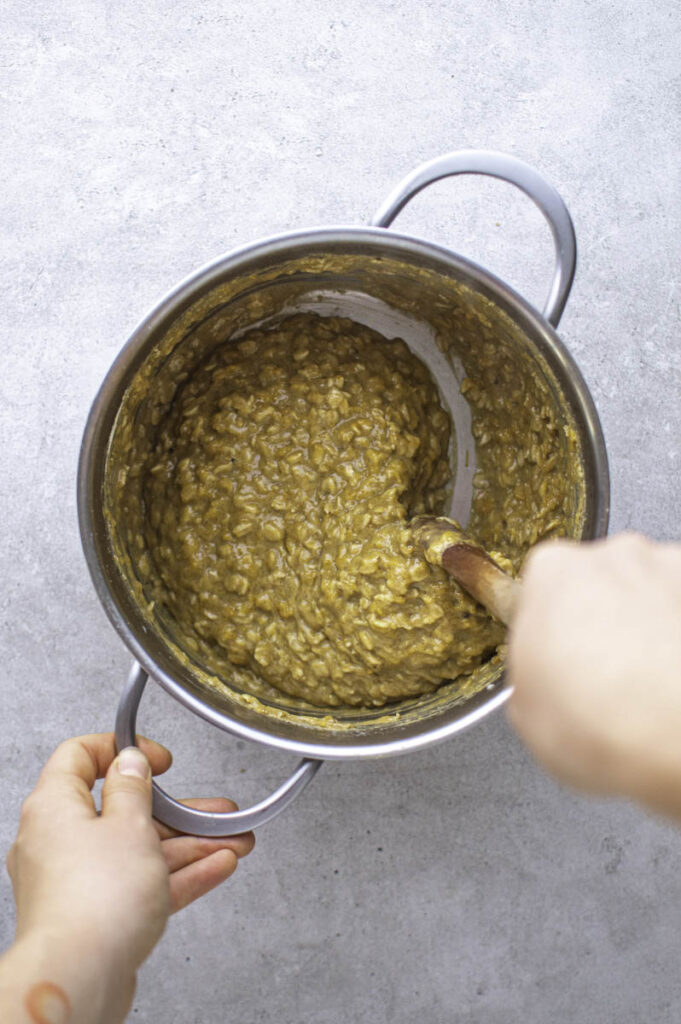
[77,225,610,760]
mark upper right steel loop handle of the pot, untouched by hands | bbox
[371,150,577,327]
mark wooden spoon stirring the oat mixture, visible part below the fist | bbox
[410,515,520,626]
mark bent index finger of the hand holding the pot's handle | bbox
[38,732,172,790]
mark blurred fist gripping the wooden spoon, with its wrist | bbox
[508,534,681,819]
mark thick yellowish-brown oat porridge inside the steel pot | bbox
[115,313,572,707]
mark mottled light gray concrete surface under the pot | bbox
[0,0,681,1024]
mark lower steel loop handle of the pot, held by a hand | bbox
[116,662,323,837]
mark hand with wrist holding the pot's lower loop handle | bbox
[0,734,254,1024]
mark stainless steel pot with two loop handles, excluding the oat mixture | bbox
[78,151,609,836]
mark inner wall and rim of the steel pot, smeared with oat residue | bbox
[87,231,607,757]
